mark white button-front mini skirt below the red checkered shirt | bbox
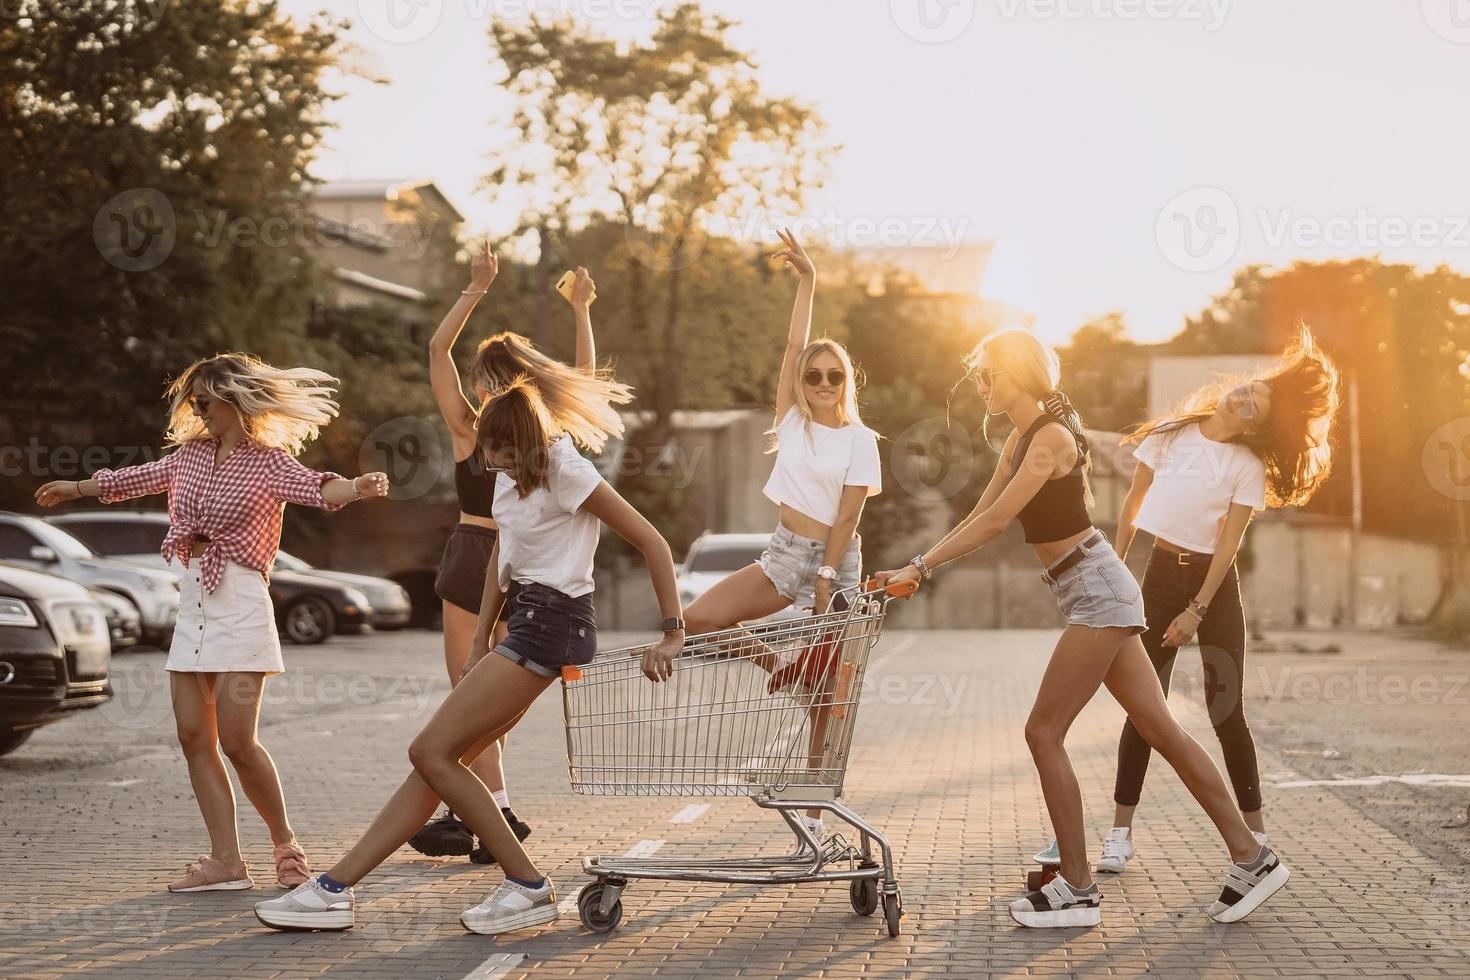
[165,558,285,674]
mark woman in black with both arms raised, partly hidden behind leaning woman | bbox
[409,244,628,864]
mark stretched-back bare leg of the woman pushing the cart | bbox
[1105,636,1261,861]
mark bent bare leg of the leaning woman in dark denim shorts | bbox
[408,654,553,880]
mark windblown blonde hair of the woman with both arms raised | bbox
[469,331,634,453]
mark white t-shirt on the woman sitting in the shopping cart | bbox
[766,407,883,526]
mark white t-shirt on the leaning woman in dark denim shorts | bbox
[491,435,603,597]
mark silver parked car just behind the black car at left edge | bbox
[0,511,179,646]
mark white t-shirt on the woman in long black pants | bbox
[1133,423,1266,554]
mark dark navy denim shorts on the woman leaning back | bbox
[495,582,597,677]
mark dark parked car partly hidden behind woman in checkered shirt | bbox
[51,510,373,645]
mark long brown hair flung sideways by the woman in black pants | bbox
[1123,325,1342,507]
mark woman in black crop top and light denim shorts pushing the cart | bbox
[878,331,1289,927]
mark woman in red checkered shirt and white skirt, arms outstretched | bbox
[35,354,388,892]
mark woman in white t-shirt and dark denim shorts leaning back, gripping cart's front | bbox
[256,381,684,934]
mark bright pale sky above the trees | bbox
[284,0,1470,341]
